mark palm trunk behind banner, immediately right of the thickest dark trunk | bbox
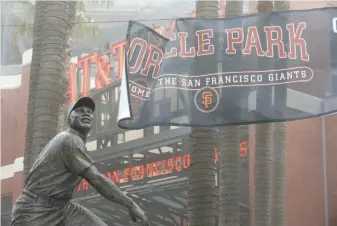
[219,0,244,226]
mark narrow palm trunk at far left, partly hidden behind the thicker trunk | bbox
[23,1,45,178]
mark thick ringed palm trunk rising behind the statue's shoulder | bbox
[31,1,68,164]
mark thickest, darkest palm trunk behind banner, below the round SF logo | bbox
[187,0,218,226]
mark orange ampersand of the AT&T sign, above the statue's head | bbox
[95,54,110,89]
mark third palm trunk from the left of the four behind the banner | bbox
[254,0,274,226]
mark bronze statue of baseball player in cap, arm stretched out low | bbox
[11,97,149,226]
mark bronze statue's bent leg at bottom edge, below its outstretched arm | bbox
[64,204,107,226]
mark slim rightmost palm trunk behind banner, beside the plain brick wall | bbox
[271,0,290,226]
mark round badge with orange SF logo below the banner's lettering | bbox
[194,87,220,113]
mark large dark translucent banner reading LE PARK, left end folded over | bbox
[118,7,337,129]
